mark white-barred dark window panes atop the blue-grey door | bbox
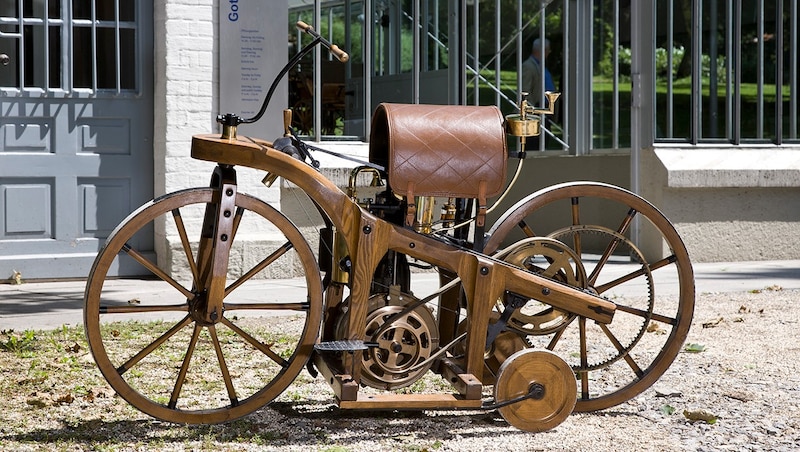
[0,0,139,94]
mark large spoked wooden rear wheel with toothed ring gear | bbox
[486,182,694,411]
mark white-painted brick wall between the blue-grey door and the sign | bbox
[153,0,304,276]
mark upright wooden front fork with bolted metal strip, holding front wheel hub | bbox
[190,164,240,325]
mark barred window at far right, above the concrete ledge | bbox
[655,0,800,144]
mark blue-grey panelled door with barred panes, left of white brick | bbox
[0,0,153,279]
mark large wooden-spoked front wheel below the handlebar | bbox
[84,188,322,424]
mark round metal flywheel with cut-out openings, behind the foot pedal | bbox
[336,291,439,390]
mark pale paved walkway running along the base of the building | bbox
[0,260,800,331]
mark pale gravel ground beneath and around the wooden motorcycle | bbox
[0,287,800,451]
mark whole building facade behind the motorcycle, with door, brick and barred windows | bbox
[0,0,800,279]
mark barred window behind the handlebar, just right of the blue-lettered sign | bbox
[288,0,459,140]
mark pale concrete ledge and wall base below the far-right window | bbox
[640,146,800,262]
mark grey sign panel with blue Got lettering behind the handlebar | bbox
[218,0,289,140]
